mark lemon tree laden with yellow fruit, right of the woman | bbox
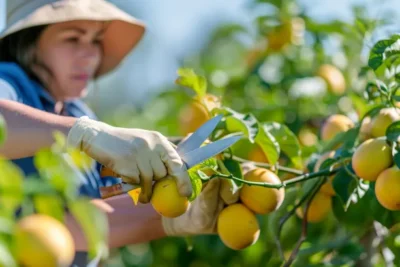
[105,0,400,266]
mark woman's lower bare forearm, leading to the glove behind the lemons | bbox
[66,194,166,251]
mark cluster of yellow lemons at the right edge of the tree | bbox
[310,107,400,225]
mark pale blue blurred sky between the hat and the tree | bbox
[0,0,400,119]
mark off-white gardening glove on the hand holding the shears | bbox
[67,116,192,203]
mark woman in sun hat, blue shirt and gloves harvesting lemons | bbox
[0,0,236,265]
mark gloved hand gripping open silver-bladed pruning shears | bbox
[67,116,240,203]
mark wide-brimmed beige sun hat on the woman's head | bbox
[0,0,146,76]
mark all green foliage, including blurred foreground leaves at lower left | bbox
[0,0,400,266]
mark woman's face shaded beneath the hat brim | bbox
[33,21,104,101]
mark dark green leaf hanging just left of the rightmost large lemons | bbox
[332,169,358,205]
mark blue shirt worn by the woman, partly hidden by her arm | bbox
[0,62,120,198]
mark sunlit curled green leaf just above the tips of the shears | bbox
[213,107,259,143]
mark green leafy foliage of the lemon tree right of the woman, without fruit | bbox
[101,0,400,266]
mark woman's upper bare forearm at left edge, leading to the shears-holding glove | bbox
[0,99,77,159]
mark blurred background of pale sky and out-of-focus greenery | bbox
[0,0,400,267]
